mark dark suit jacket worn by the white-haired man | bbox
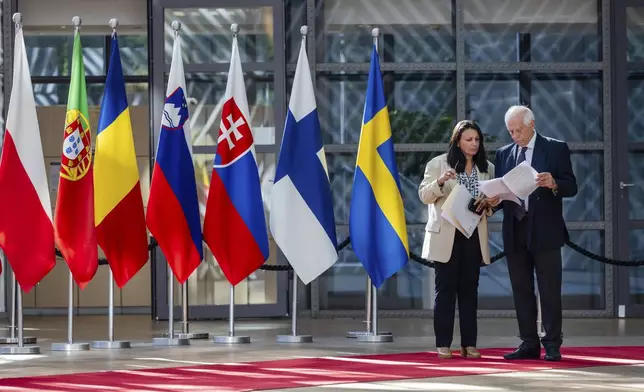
[495,134,577,253]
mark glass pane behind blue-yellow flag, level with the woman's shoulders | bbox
[327,152,441,225]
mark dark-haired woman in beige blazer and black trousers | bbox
[418,120,499,358]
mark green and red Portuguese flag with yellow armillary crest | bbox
[54,31,98,289]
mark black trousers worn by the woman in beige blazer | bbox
[434,229,482,347]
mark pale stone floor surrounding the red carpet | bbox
[0,316,644,391]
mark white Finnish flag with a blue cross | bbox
[271,35,338,284]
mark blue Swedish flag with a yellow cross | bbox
[349,45,409,287]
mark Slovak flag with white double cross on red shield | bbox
[203,32,268,286]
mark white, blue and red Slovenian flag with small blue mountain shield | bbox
[146,33,203,284]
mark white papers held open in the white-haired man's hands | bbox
[479,161,538,204]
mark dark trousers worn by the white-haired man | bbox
[507,217,562,348]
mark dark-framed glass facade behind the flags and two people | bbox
[0,0,644,317]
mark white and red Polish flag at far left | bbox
[0,26,56,292]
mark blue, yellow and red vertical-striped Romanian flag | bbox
[94,33,148,288]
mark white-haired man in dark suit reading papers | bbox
[495,106,577,361]
